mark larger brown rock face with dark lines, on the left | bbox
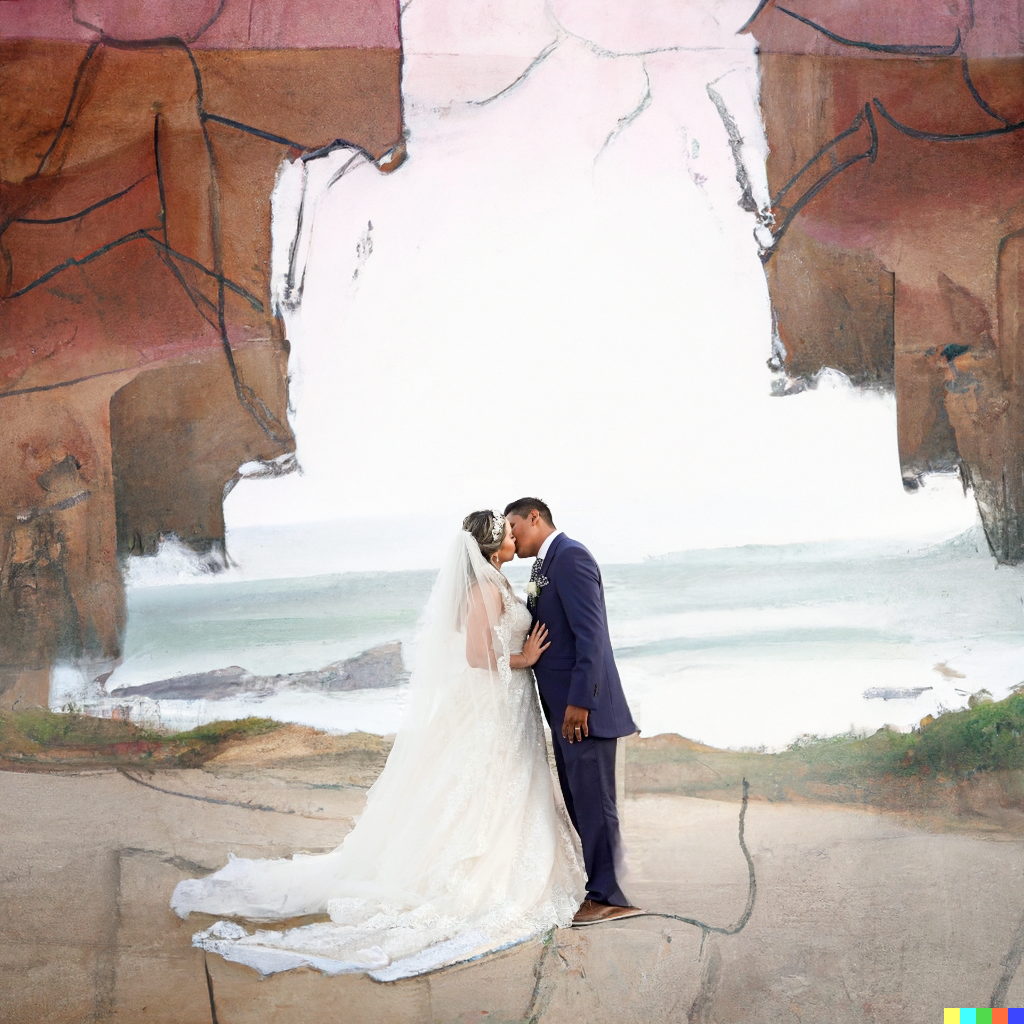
[0,0,402,703]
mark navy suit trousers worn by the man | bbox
[551,729,630,906]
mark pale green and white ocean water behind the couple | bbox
[70,530,1024,750]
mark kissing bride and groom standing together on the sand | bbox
[171,498,643,981]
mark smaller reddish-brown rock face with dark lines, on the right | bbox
[749,0,1024,563]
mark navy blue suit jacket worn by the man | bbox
[532,534,637,739]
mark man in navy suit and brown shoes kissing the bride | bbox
[505,498,643,925]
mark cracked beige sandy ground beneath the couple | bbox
[0,735,1024,1024]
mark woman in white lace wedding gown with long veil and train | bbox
[171,511,586,981]
